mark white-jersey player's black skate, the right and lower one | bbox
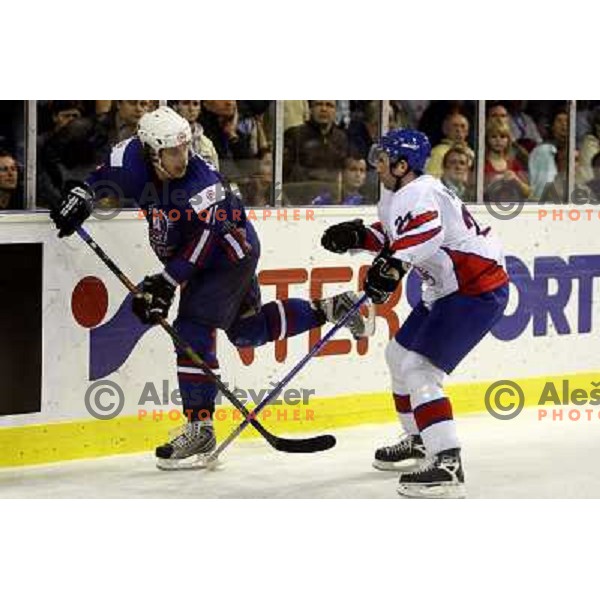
[398,448,466,498]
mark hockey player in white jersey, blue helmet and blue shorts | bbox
[322,129,508,497]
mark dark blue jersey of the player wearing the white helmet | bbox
[86,137,259,284]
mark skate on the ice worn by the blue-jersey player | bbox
[155,421,217,471]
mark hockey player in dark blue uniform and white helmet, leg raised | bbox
[51,107,364,469]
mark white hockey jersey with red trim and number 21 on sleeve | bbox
[366,175,508,304]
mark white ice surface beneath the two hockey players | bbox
[0,407,600,498]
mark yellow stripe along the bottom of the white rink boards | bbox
[0,373,600,467]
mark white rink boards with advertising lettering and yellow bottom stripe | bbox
[0,207,600,466]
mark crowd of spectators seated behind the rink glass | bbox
[0,100,600,210]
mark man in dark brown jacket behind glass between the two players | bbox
[283,100,348,204]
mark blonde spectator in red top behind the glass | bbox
[484,117,531,201]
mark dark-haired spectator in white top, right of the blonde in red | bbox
[529,109,569,200]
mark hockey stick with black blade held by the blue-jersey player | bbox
[75,226,335,453]
